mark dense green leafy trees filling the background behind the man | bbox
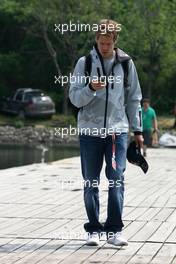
[0,0,176,113]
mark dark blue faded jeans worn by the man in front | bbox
[79,133,128,233]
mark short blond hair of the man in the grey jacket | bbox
[96,19,121,42]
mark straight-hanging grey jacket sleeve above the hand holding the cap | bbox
[127,60,142,134]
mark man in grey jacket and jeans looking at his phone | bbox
[69,19,143,246]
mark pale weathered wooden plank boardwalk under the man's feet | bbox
[0,149,176,264]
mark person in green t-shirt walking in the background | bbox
[142,98,158,157]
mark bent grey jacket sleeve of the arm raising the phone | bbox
[69,57,96,108]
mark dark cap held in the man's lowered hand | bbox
[127,141,149,173]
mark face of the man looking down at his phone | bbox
[96,35,114,58]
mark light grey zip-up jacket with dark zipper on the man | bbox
[69,46,142,136]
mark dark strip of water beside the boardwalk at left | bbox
[0,145,80,169]
